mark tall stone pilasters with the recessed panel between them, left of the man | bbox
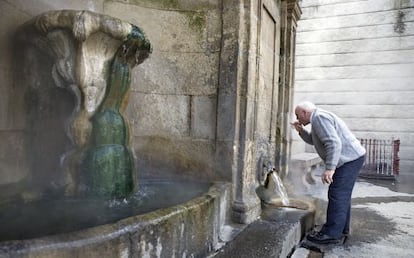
[217,0,298,223]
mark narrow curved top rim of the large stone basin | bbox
[0,182,231,256]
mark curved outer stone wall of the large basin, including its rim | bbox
[0,182,231,257]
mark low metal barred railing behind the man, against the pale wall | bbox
[359,139,400,179]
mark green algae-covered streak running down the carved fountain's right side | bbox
[80,26,151,198]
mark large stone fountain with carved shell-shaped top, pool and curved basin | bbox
[0,10,229,257]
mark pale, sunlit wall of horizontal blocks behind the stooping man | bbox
[292,0,414,174]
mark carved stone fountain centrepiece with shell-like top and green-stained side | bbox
[18,10,152,198]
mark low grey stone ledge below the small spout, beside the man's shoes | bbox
[208,203,315,258]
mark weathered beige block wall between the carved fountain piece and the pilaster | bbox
[104,1,225,180]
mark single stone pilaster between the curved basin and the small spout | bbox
[217,0,261,223]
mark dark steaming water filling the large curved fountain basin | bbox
[0,181,211,241]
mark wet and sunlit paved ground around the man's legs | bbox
[292,171,414,258]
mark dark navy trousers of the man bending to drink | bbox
[322,156,365,238]
